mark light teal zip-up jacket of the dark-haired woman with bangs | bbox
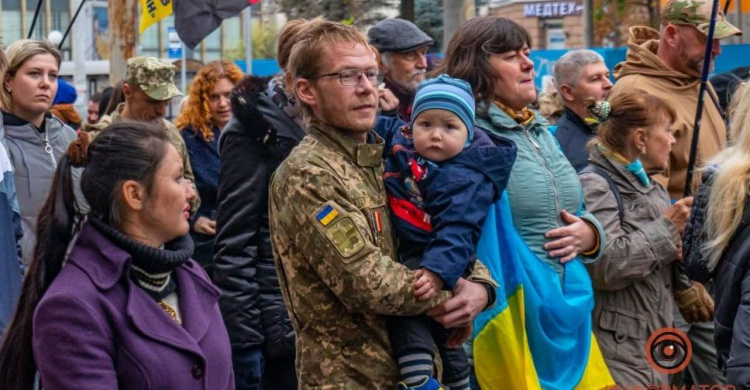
[477,104,606,277]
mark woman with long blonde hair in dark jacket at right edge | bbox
[700,83,750,389]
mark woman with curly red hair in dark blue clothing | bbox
[175,60,243,267]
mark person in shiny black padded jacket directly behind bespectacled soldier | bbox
[214,19,316,390]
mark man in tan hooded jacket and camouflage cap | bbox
[609,0,742,385]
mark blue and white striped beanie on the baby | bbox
[411,74,474,146]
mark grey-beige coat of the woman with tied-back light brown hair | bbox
[580,150,689,388]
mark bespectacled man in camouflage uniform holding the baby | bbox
[269,22,494,389]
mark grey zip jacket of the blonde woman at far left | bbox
[3,112,80,266]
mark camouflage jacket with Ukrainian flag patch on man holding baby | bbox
[269,120,500,390]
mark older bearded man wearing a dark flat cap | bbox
[367,18,434,122]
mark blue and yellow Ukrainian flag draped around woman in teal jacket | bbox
[473,194,615,390]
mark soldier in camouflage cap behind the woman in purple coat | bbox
[81,57,200,213]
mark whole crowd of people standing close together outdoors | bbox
[0,0,750,390]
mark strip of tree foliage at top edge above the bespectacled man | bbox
[278,0,393,26]
